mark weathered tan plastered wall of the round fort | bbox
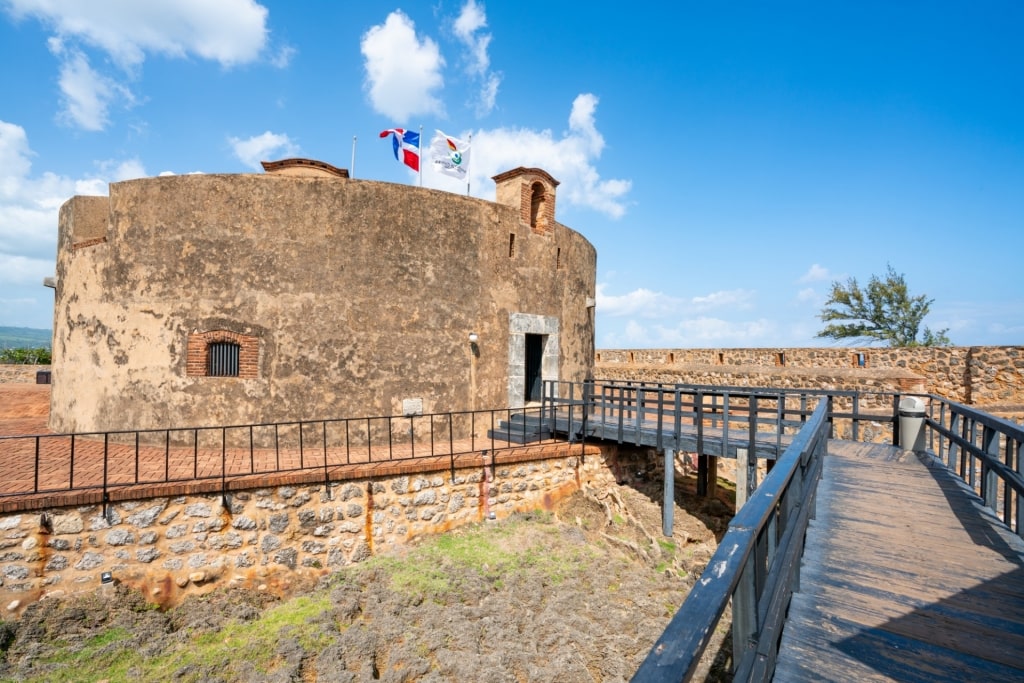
[50,175,596,432]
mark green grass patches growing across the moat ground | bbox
[3,518,595,683]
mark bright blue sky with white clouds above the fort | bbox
[0,0,1024,348]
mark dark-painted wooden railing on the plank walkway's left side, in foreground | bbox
[633,401,830,683]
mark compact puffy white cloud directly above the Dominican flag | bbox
[359,10,444,121]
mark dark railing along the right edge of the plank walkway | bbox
[924,394,1024,537]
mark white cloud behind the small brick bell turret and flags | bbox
[436,93,633,218]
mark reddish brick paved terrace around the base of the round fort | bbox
[0,384,579,511]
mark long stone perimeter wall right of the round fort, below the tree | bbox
[595,346,1024,408]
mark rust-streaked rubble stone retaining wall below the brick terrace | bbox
[0,446,615,618]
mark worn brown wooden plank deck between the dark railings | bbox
[774,441,1024,683]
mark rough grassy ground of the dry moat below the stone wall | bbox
[0,480,730,683]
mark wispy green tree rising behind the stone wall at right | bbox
[817,265,950,346]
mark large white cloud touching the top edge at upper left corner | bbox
[2,0,276,131]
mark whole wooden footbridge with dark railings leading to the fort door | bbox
[540,384,1024,683]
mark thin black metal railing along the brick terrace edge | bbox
[0,404,555,500]
